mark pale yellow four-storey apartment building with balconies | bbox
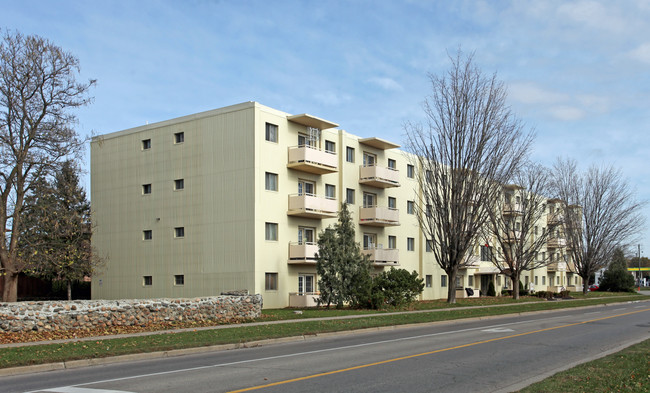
[91,102,580,308]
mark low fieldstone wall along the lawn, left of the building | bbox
[0,295,262,332]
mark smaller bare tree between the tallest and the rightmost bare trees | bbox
[486,163,561,299]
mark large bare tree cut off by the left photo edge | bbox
[0,32,95,302]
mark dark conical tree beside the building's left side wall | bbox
[20,161,99,300]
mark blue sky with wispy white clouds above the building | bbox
[0,0,650,256]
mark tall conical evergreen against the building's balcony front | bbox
[316,203,371,308]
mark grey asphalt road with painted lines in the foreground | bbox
[5,302,650,393]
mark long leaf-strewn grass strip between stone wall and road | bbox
[0,292,642,368]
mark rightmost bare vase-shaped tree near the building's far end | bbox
[554,159,645,293]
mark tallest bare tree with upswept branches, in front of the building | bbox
[405,51,533,303]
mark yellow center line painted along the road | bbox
[229,308,650,393]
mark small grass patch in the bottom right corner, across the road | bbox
[520,339,650,393]
